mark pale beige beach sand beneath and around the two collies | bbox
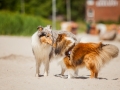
[0,35,120,90]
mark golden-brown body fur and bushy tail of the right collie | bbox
[64,40,119,78]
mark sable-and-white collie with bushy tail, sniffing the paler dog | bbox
[41,34,119,78]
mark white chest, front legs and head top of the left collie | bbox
[32,26,52,77]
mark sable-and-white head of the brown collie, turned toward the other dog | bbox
[41,34,75,55]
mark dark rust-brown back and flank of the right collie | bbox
[70,43,102,66]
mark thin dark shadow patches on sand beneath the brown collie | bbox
[54,74,119,80]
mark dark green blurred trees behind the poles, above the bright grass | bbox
[0,0,86,20]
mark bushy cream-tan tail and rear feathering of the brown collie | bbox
[95,44,119,70]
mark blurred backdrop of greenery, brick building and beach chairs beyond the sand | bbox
[0,0,120,40]
